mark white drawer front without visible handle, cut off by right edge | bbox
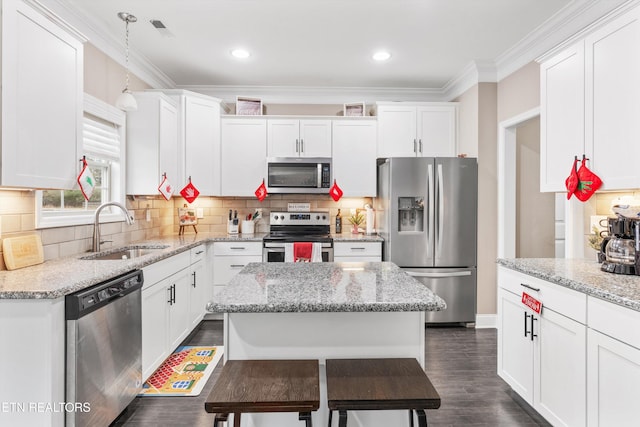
[587,296,640,349]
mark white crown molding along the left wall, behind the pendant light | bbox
[40,0,176,88]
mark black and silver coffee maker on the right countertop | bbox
[600,215,640,275]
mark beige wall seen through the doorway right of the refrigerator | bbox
[516,117,555,258]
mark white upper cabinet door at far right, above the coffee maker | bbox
[585,8,640,189]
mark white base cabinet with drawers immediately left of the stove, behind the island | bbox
[213,241,262,300]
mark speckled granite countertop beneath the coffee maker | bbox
[498,258,640,311]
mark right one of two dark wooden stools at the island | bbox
[327,359,440,427]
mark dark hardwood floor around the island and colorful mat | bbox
[112,321,549,427]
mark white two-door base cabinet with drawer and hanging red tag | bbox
[498,267,587,426]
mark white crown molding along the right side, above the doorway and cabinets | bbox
[495,0,637,81]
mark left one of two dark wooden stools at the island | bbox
[204,360,320,427]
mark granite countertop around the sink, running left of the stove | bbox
[0,233,266,300]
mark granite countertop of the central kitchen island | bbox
[207,262,446,313]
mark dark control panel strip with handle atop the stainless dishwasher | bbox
[65,270,144,320]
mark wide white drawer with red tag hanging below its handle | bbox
[498,267,587,324]
